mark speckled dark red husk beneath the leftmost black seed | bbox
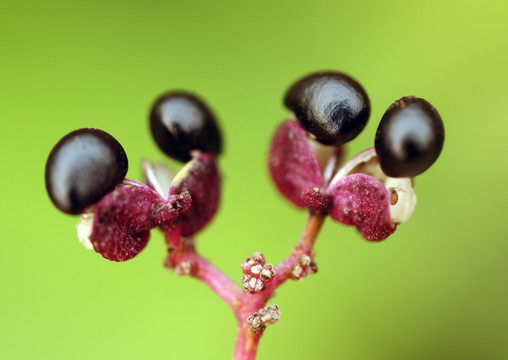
[90,179,185,261]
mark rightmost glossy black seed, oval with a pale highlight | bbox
[375,96,444,177]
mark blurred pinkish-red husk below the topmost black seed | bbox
[268,120,323,207]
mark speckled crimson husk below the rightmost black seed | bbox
[325,174,398,241]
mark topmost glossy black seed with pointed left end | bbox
[284,72,370,145]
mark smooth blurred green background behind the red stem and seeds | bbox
[0,0,508,359]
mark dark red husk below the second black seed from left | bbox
[169,153,221,236]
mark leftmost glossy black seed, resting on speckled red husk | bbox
[45,128,128,214]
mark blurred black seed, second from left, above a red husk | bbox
[150,91,222,162]
